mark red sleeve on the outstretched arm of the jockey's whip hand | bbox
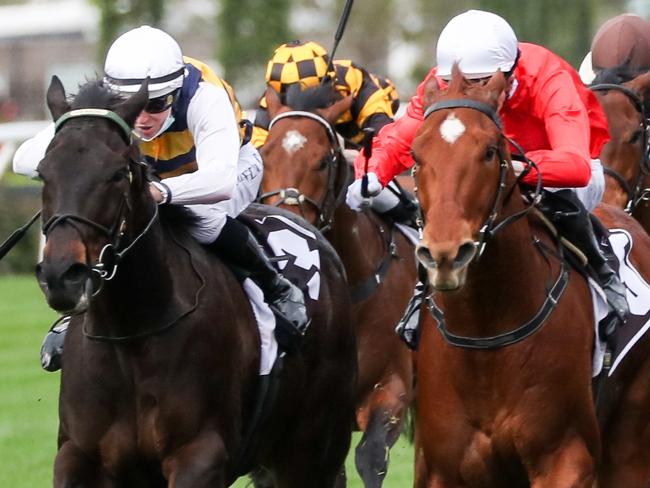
[354,69,435,186]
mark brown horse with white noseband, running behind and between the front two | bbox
[261,87,415,488]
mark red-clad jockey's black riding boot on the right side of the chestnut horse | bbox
[541,190,629,338]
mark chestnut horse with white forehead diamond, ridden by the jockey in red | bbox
[412,67,650,488]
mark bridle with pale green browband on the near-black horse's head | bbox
[42,109,158,296]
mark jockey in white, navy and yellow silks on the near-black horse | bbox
[14,26,308,370]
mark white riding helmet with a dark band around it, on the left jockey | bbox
[104,25,185,98]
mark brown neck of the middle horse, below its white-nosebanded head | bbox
[326,203,390,284]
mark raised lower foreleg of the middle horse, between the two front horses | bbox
[355,375,406,488]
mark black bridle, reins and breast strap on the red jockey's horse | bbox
[421,99,569,349]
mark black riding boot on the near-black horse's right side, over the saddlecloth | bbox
[210,217,309,352]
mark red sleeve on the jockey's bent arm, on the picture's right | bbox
[523,71,591,188]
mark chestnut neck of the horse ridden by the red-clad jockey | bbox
[435,192,557,336]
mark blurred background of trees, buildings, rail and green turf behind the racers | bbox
[0,0,650,488]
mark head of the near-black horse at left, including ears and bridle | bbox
[36,76,150,314]
